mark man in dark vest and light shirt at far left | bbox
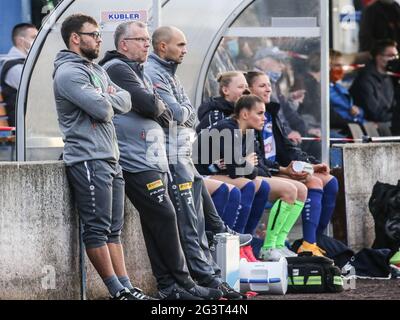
[0,23,38,127]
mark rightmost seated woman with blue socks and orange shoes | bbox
[246,72,339,256]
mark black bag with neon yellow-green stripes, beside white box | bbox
[286,253,343,293]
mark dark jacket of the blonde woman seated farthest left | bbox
[196,97,235,133]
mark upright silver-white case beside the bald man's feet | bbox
[212,233,240,291]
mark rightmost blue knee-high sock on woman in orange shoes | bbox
[317,177,339,234]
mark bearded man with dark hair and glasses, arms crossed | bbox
[53,14,151,300]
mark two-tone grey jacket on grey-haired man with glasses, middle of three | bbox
[99,51,172,173]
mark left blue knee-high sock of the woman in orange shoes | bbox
[301,189,323,243]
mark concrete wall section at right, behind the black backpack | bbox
[340,143,400,251]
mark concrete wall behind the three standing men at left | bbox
[0,162,155,299]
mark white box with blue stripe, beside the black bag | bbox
[240,258,288,295]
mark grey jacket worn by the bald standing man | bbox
[145,53,196,164]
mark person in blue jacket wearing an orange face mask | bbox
[329,50,365,136]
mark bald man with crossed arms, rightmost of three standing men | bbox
[146,26,245,299]
